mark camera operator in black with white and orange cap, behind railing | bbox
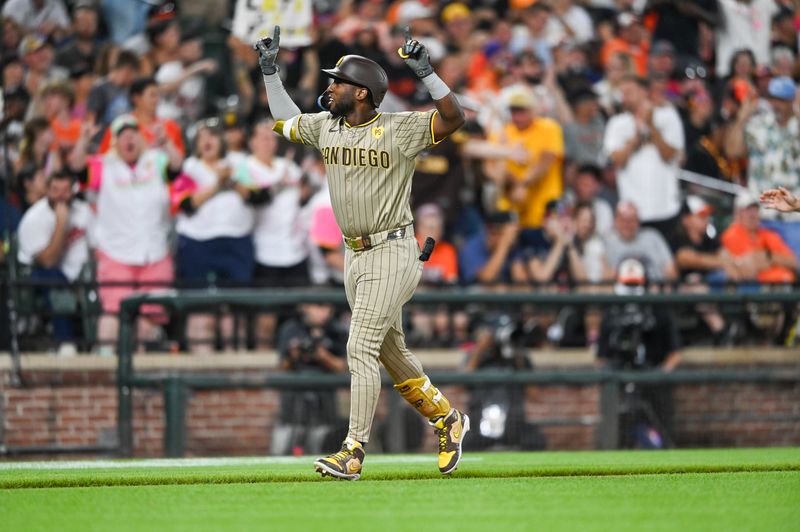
[597,258,681,449]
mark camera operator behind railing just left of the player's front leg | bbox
[272,303,347,454]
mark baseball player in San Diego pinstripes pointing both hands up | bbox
[255,27,469,480]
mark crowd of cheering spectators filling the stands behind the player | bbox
[0,0,800,356]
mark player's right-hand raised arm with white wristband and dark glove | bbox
[397,27,464,142]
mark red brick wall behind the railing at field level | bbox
[0,370,800,456]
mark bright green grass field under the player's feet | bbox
[0,449,800,532]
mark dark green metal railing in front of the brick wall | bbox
[117,289,800,456]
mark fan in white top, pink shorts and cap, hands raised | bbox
[70,114,183,352]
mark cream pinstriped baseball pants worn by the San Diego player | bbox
[345,235,423,442]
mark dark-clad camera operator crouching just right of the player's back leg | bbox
[465,313,546,450]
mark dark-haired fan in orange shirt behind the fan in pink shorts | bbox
[98,78,186,156]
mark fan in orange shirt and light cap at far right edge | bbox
[722,192,798,283]
